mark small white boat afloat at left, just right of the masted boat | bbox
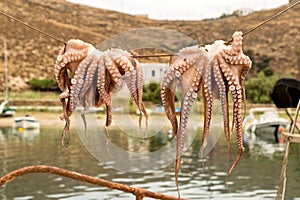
[13,115,40,129]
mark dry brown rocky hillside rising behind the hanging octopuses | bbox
[0,0,300,91]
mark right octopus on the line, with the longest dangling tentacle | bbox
[161,31,252,195]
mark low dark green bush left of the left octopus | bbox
[28,78,58,91]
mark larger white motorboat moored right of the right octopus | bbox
[243,107,290,142]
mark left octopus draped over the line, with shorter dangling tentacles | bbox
[55,39,148,145]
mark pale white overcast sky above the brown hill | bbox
[68,0,288,20]
